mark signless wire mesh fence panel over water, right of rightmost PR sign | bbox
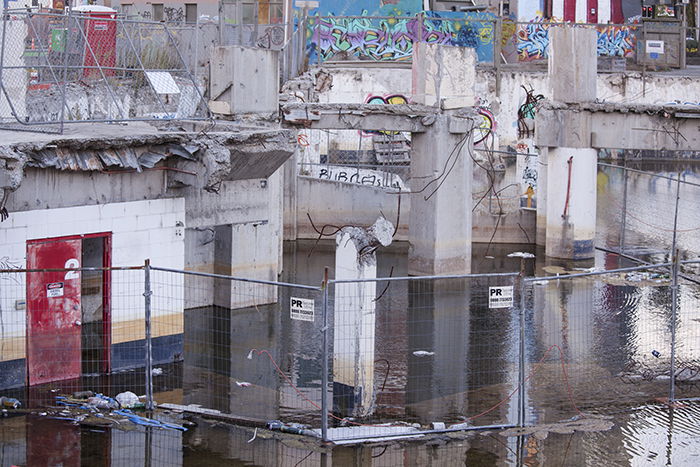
[525,266,673,424]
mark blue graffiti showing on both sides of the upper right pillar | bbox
[516,17,638,62]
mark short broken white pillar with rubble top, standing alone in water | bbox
[333,218,394,417]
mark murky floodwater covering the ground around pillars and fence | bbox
[0,163,700,466]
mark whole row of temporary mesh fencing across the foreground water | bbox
[0,256,700,444]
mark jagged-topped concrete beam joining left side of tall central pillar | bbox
[282,103,439,133]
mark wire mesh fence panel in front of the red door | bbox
[0,268,145,407]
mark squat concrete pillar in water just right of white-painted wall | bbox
[214,221,279,309]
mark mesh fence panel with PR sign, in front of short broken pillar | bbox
[328,275,519,438]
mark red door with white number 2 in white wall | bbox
[27,239,81,385]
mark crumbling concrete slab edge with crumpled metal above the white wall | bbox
[0,128,296,191]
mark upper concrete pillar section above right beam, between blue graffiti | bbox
[548,26,598,103]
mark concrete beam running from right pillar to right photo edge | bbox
[535,106,700,151]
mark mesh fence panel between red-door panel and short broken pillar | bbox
[152,268,321,426]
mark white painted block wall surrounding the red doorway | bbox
[0,198,185,348]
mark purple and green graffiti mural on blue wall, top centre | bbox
[307,12,496,63]
